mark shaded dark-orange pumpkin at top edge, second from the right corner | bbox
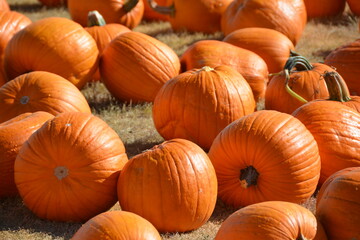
[304,0,346,18]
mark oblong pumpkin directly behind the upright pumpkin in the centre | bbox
[180,40,269,106]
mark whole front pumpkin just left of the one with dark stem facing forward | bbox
[118,139,217,232]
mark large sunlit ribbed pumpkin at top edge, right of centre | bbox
[221,0,307,46]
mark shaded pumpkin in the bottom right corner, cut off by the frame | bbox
[316,167,360,240]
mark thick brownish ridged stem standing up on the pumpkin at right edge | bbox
[324,72,351,102]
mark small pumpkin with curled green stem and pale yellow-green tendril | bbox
[265,56,334,114]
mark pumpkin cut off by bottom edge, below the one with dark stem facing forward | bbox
[215,201,317,240]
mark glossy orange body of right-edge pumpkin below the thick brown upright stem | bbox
[293,100,360,186]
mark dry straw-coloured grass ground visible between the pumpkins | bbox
[0,0,360,240]
